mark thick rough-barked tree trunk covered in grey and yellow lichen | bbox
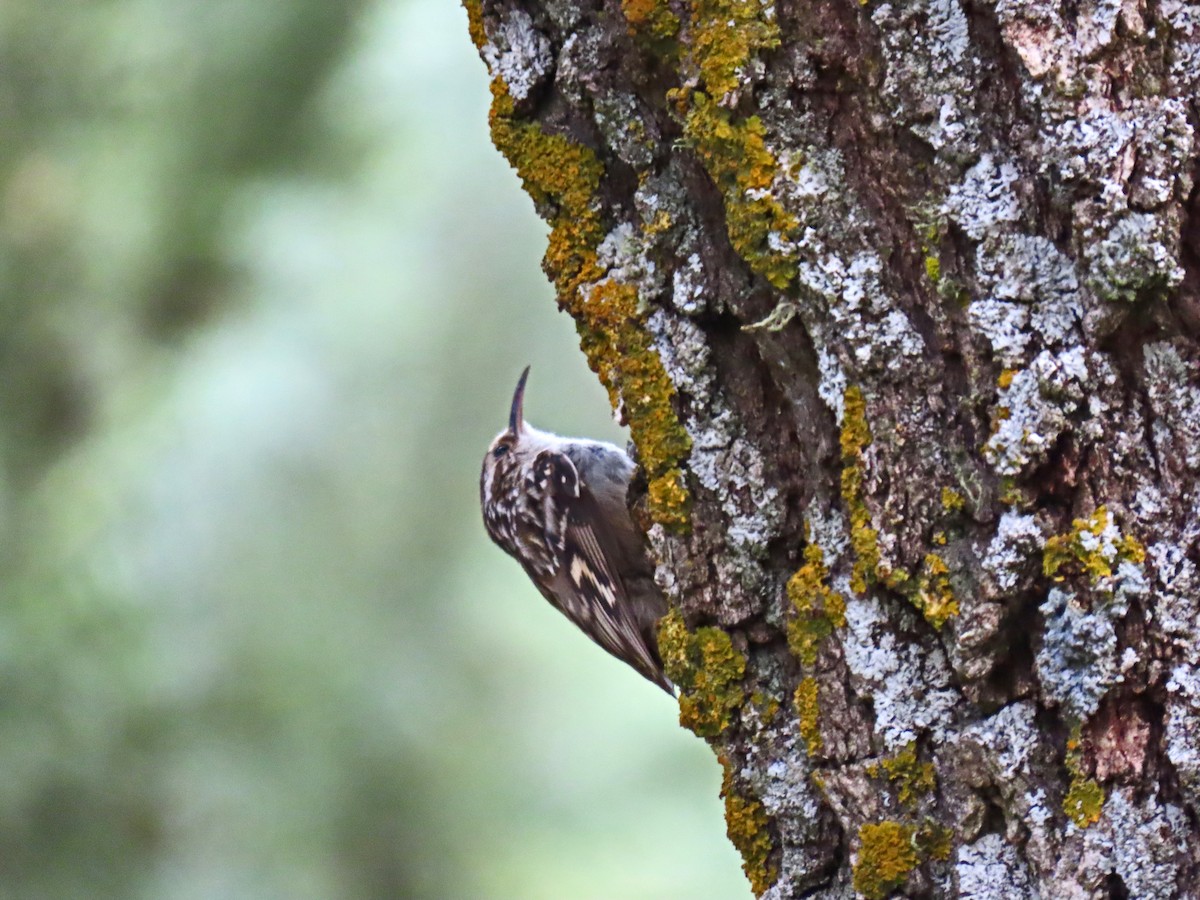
[468,0,1200,898]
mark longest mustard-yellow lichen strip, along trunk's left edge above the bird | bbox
[491,78,691,532]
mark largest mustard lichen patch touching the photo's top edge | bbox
[690,0,779,100]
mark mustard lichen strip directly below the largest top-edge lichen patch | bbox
[684,92,799,288]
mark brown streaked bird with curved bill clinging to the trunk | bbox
[479,366,674,697]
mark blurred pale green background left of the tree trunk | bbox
[0,0,749,900]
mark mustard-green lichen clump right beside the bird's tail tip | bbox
[659,610,746,738]
